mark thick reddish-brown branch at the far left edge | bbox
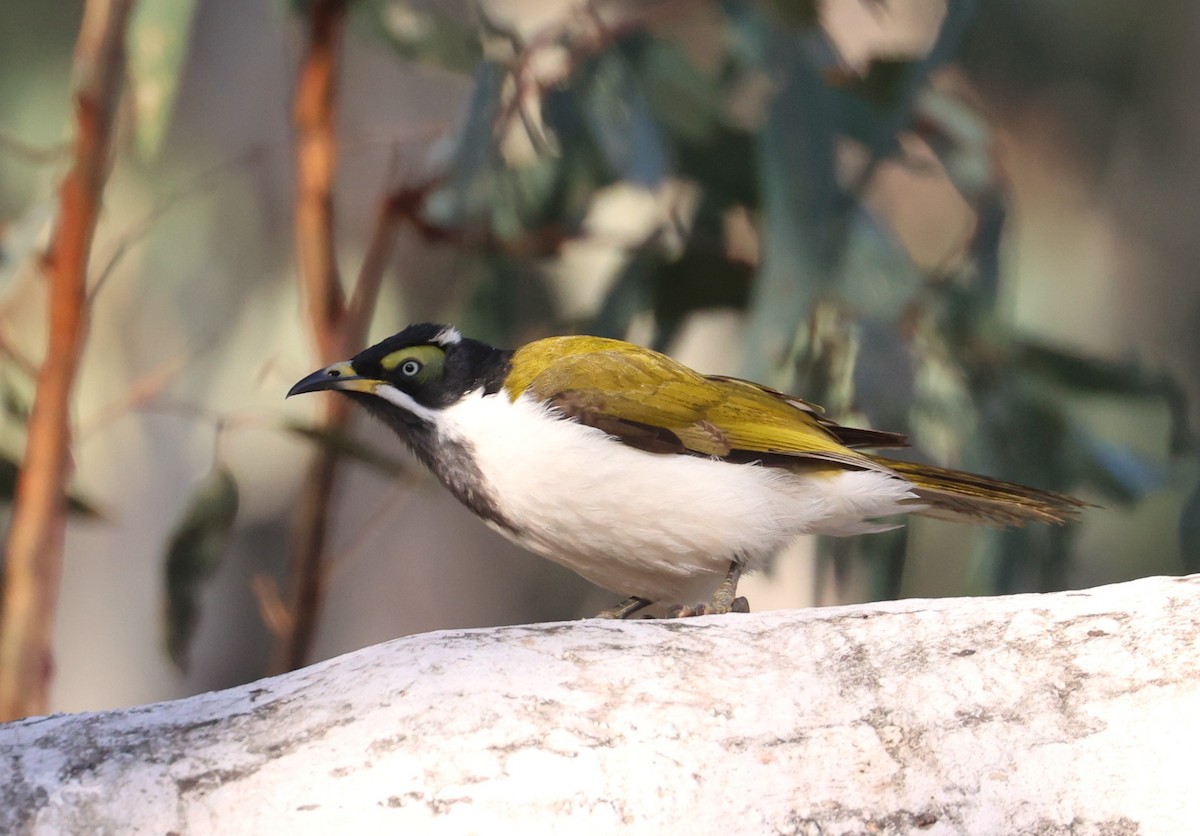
[0,0,133,721]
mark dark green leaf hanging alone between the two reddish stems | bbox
[164,468,238,670]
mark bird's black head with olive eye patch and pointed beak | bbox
[288,323,511,431]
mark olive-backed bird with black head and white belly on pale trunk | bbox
[287,323,1086,618]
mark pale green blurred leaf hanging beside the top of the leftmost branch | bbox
[128,0,196,160]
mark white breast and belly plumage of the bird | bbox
[442,391,916,603]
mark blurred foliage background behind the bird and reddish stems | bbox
[0,0,1200,710]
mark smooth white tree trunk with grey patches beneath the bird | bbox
[0,576,1200,834]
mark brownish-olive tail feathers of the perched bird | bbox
[871,456,1088,527]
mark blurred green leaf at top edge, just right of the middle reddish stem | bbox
[358,0,484,73]
